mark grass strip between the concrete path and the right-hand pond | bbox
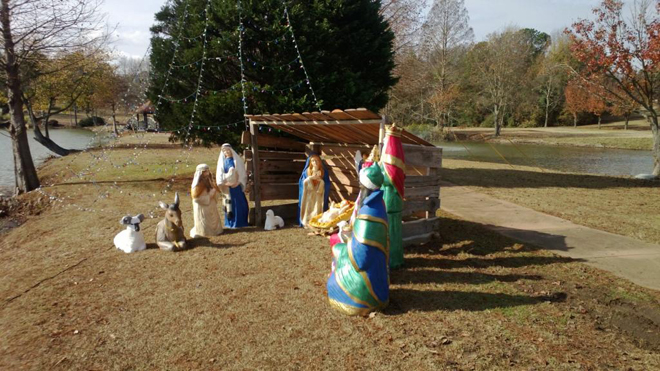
[442,159,660,243]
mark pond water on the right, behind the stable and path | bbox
[437,142,653,176]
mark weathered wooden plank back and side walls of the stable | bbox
[243,129,442,245]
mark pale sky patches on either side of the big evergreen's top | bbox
[104,0,620,58]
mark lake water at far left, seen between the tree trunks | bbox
[0,129,96,194]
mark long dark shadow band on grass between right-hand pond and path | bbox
[440,168,660,189]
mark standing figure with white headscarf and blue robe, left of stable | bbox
[216,143,249,228]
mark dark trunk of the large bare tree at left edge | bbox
[0,0,40,194]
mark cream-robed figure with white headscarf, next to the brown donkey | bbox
[190,164,222,238]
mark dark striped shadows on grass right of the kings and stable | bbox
[385,214,577,315]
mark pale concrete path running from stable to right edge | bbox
[440,182,660,290]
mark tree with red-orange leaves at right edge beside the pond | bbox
[566,0,660,177]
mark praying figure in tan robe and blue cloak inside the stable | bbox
[298,153,330,228]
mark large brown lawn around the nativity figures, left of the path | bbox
[0,134,660,370]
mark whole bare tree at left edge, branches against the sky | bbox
[0,0,105,193]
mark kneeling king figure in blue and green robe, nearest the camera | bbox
[326,164,390,315]
